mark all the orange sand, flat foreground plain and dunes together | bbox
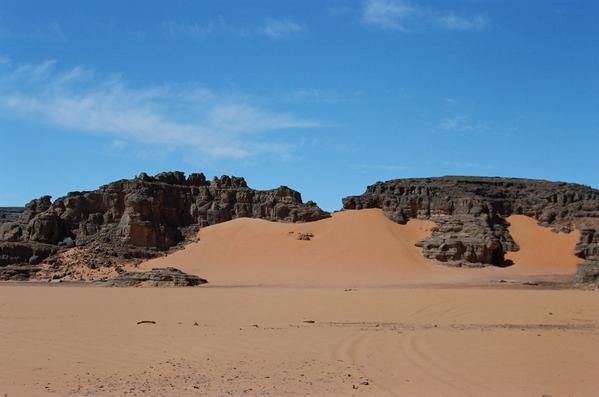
[0,211,599,397]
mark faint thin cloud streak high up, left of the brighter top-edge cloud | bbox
[162,17,305,39]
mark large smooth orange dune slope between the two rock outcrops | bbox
[142,209,464,285]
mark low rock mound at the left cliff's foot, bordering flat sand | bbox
[98,267,208,287]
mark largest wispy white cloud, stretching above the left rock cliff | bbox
[0,61,321,158]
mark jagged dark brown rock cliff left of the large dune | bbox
[0,172,329,279]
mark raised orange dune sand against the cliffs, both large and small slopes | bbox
[140,209,579,286]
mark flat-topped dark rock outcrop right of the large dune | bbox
[343,177,599,266]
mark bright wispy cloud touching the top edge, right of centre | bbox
[362,0,490,32]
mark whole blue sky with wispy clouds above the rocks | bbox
[0,0,599,210]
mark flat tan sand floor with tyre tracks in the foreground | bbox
[0,286,599,397]
